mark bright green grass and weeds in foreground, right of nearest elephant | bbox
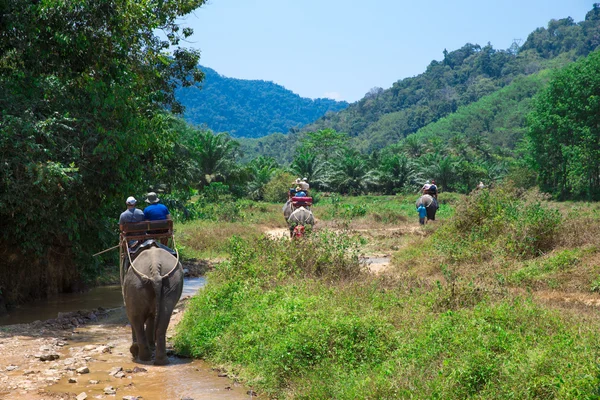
[175,232,600,399]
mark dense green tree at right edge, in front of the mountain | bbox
[528,51,600,200]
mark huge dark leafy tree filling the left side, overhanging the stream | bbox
[0,0,204,299]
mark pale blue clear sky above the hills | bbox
[182,0,593,102]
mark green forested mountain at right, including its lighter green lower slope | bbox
[242,5,600,162]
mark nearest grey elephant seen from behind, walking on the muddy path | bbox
[121,243,183,365]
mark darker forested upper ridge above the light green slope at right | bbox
[304,5,600,151]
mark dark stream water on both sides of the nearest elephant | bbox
[0,277,206,325]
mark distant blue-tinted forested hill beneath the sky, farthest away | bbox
[176,66,348,138]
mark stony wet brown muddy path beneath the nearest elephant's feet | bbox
[0,298,257,400]
